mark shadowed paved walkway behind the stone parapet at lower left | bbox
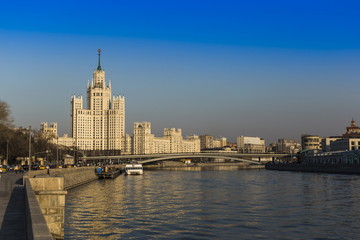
[0,173,27,240]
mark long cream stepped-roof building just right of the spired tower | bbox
[132,122,200,154]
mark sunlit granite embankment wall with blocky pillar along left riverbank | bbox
[24,167,98,240]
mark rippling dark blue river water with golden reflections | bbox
[65,167,360,240]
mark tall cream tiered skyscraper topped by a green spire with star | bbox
[71,49,125,153]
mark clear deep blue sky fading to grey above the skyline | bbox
[0,0,360,144]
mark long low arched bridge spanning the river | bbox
[79,152,290,164]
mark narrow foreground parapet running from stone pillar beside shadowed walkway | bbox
[24,179,54,240]
